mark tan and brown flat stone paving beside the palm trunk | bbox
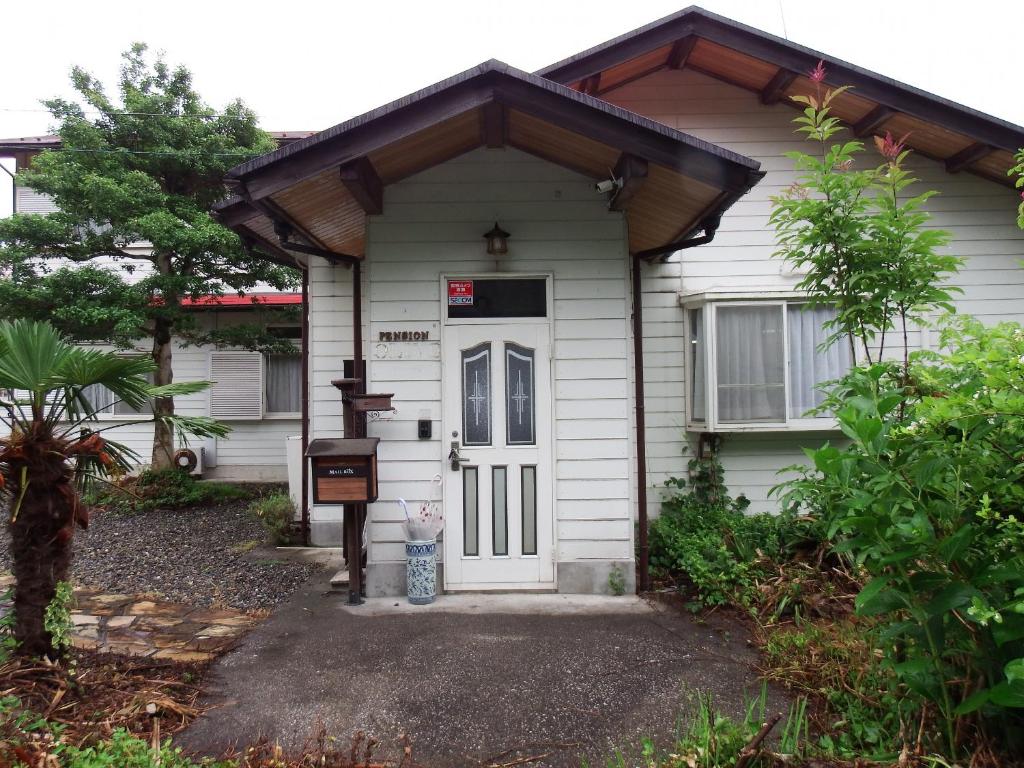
[0,573,262,662]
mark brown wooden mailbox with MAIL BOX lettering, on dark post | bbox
[306,437,380,504]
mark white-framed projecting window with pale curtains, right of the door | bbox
[687,301,852,430]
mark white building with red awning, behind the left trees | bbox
[0,132,309,481]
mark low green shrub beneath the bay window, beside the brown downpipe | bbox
[649,458,802,606]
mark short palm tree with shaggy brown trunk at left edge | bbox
[0,321,227,658]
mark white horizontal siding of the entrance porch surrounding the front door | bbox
[310,150,632,562]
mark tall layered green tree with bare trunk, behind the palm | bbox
[0,44,295,469]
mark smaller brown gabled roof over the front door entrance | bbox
[217,60,763,258]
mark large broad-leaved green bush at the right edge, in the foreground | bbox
[785,321,1024,758]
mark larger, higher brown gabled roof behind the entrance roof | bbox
[537,6,1024,184]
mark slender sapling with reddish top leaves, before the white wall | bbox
[770,63,959,371]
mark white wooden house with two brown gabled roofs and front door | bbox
[219,8,1024,595]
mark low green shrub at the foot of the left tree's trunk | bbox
[86,469,251,513]
